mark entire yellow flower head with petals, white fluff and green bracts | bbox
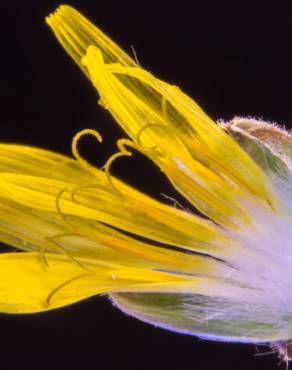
[0,2,292,356]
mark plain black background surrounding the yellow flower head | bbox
[0,0,292,370]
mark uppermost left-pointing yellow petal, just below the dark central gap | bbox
[0,144,234,255]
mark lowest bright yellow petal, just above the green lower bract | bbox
[0,253,244,313]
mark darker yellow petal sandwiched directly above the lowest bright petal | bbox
[0,199,227,277]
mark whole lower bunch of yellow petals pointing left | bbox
[0,144,262,313]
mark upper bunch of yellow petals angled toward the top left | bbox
[47,6,274,227]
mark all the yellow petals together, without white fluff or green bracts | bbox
[0,6,274,324]
